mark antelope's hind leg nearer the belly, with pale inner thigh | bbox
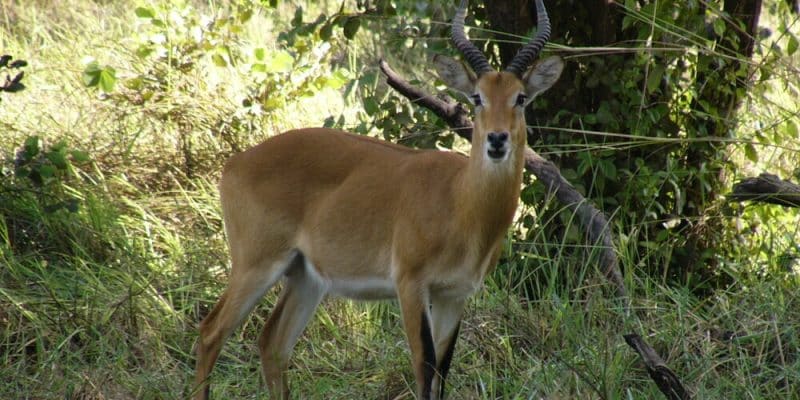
[258,254,326,399]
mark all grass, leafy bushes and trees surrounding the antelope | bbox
[0,0,800,399]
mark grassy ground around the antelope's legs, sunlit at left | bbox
[0,0,800,399]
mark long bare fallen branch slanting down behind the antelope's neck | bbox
[380,60,629,300]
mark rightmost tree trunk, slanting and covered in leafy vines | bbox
[676,0,761,270]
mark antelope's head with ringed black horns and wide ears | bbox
[434,0,564,164]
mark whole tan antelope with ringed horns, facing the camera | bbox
[194,0,563,400]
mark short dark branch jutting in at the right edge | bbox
[728,173,800,207]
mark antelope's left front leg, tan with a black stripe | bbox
[397,280,436,400]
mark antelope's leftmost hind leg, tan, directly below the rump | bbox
[193,251,297,400]
